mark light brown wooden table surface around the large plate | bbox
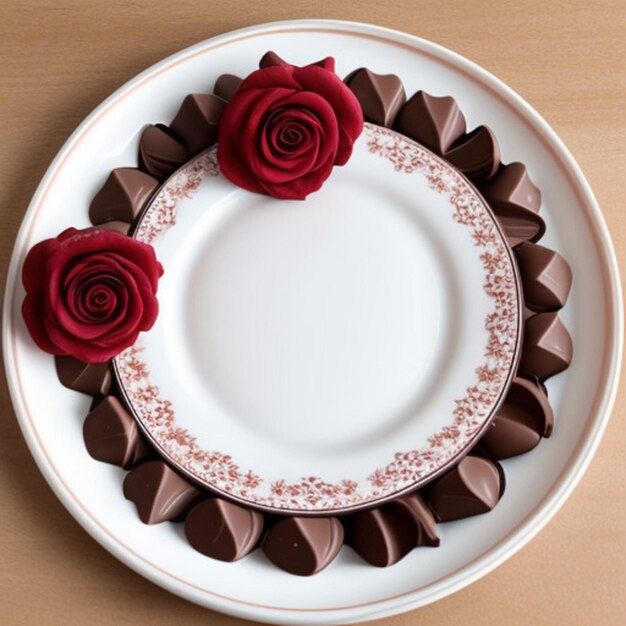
[0,0,626,626]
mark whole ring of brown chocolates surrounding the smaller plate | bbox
[55,52,572,576]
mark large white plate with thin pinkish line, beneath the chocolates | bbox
[3,20,623,624]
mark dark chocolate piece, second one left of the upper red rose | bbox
[170,94,226,156]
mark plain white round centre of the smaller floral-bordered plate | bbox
[178,172,446,451]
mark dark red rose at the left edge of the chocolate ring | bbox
[22,228,163,363]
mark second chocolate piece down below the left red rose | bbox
[83,396,150,469]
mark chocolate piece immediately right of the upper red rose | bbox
[346,68,406,128]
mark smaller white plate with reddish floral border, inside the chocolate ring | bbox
[114,124,521,514]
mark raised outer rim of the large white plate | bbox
[2,19,624,624]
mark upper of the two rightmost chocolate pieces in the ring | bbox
[515,243,572,311]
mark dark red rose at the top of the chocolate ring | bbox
[217,58,363,200]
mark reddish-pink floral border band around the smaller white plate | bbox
[115,124,521,511]
